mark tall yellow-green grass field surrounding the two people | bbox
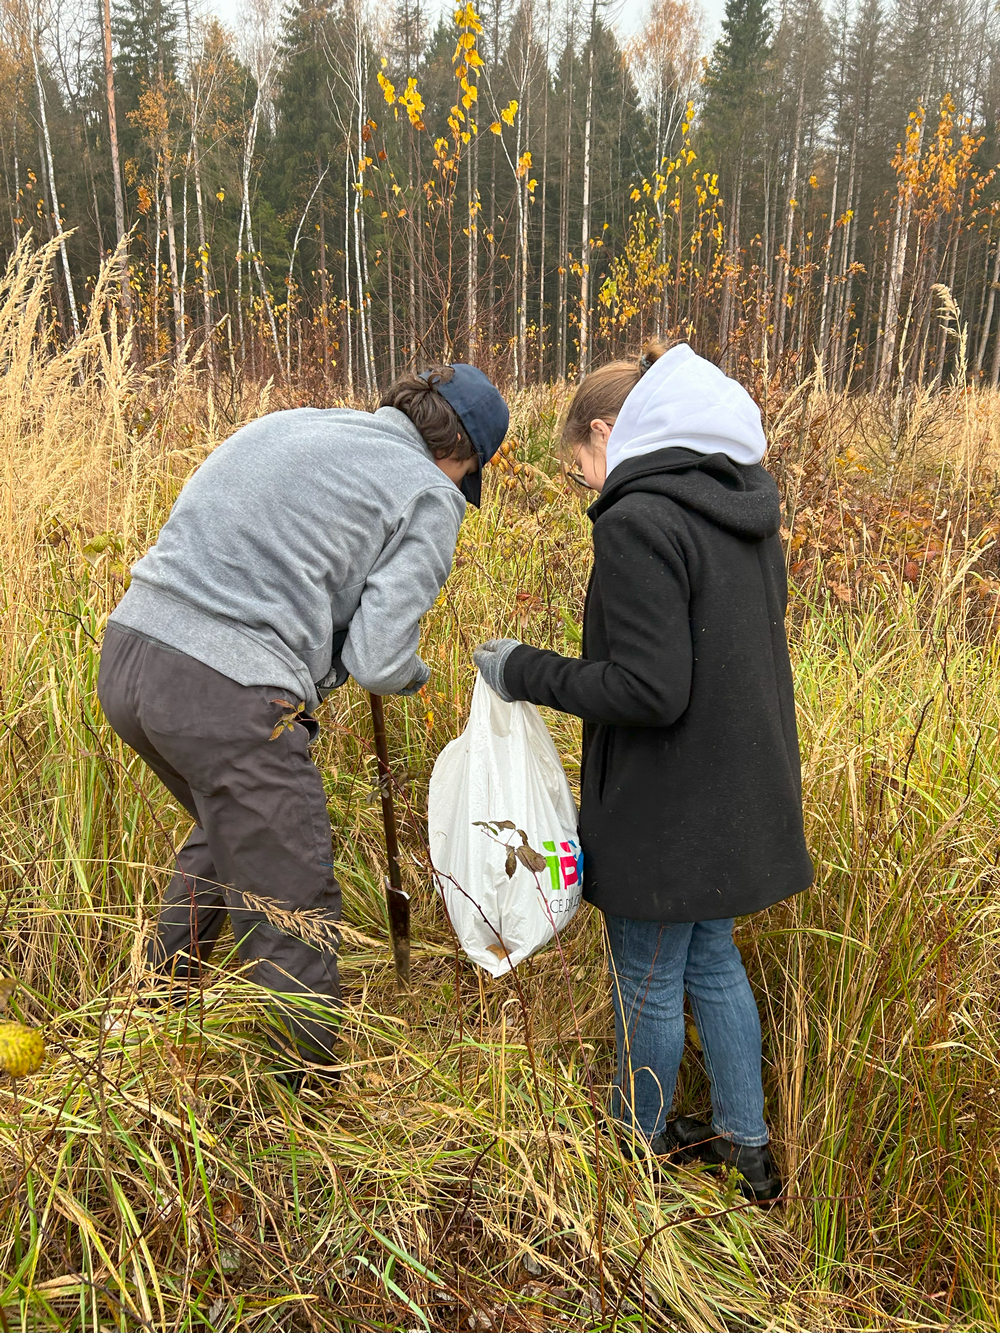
[0,242,1000,1333]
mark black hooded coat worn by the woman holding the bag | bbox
[504,448,812,921]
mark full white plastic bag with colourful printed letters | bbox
[427,676,583,977]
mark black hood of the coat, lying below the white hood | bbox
[587,447,781,541]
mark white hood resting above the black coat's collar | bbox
[607,343,767,476]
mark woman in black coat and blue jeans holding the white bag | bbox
[475,344,813,1200]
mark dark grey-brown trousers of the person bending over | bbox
[97,624,340,1064]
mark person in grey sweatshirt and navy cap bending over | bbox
[97,364,508,1085]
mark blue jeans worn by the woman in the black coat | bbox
[604,916,768,1148]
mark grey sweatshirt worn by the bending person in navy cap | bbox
[111,408,465,708]
